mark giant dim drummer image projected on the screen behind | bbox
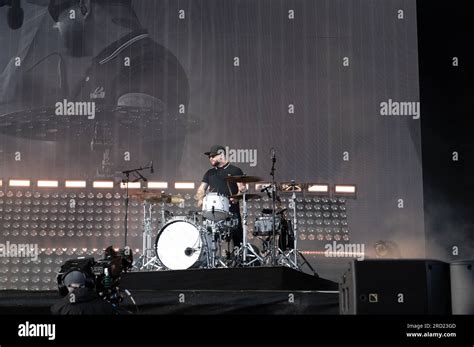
[0,0,190,178]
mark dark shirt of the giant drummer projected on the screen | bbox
[73,30,189,115]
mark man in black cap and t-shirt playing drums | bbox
[195,145,246,247]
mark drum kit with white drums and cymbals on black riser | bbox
[130,175,316,274]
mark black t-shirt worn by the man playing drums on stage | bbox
[202,163,244,214]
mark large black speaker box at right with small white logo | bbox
[339,259,451,314]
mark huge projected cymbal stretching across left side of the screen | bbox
[0,105,199,143]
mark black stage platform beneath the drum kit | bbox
[0,267,339,315]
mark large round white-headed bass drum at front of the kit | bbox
[155,219,210,270]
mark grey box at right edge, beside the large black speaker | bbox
[450,260,474,315]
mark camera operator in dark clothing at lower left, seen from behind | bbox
[51,271,119,315]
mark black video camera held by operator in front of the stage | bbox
[57,246,133,304]
